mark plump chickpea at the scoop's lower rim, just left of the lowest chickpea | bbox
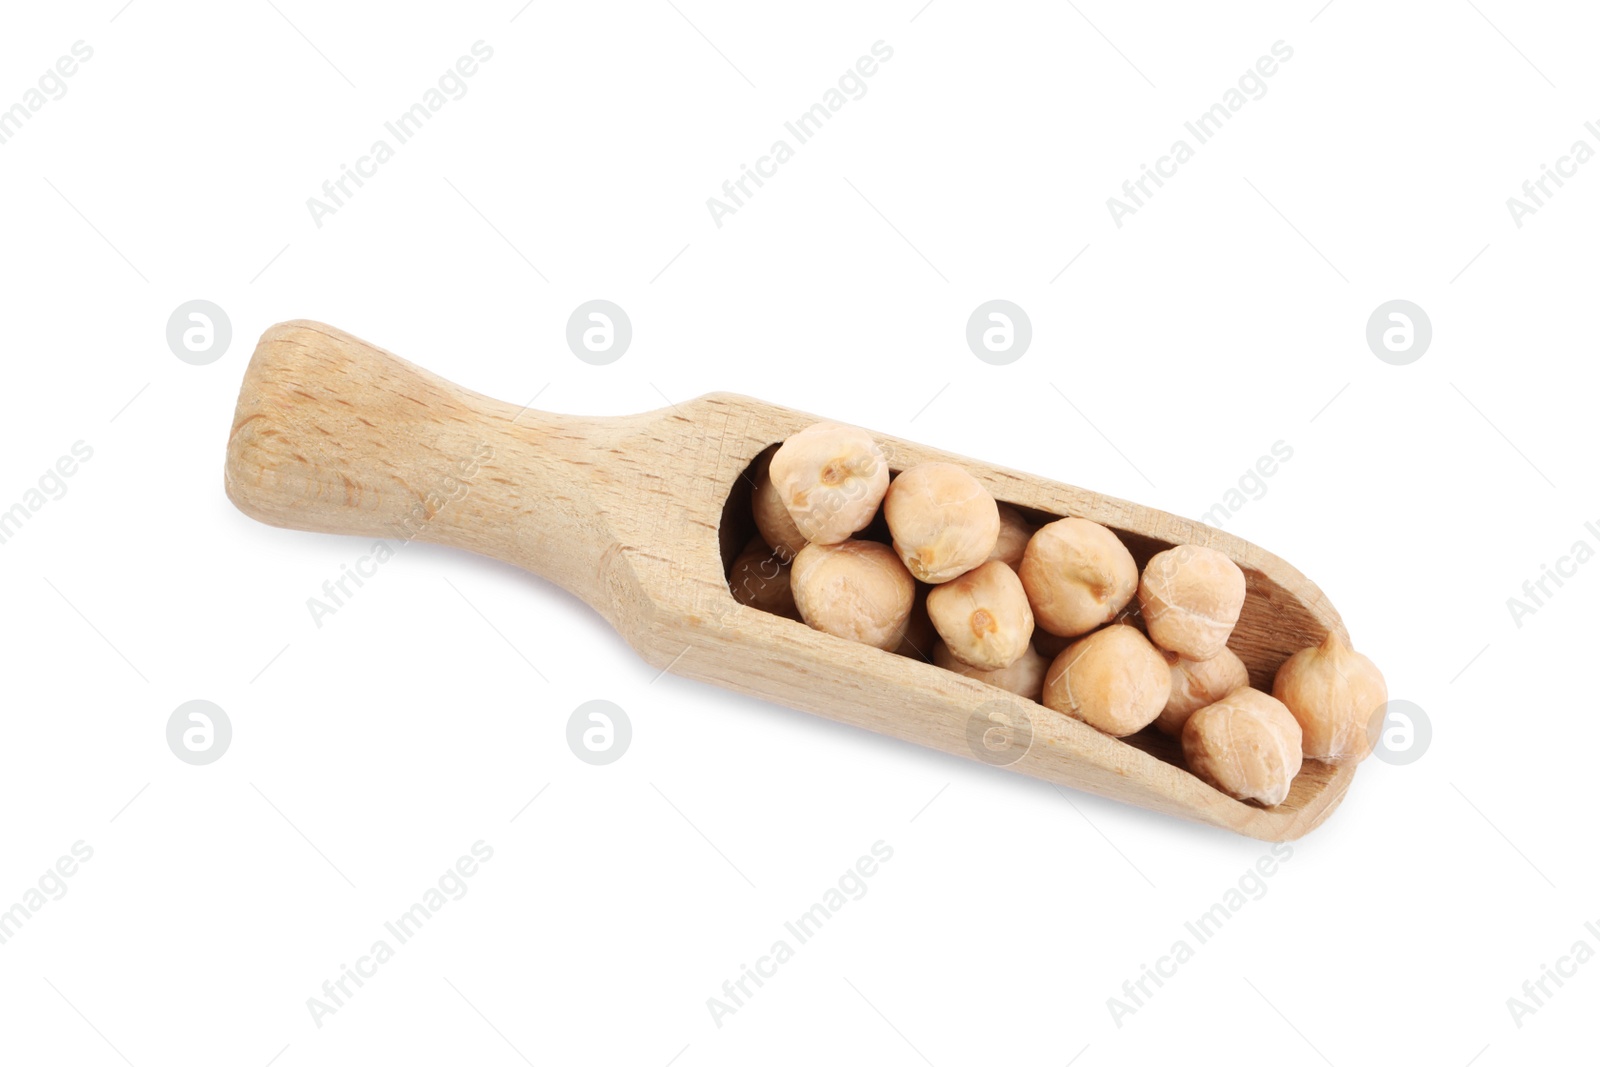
[1043,625,1173,737]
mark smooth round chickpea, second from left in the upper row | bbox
[883,462,1000,584]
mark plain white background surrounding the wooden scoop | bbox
[0,0,1600,1067]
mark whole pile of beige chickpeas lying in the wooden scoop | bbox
[730,422,1387,806]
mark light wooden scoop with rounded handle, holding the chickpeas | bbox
[224,322,1355,841]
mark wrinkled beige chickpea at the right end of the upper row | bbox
[1139,544,1245,659]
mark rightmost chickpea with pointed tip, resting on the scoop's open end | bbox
[1272,632,1389,763]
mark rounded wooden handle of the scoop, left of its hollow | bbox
[224,320,616,617]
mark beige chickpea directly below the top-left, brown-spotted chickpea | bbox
[789,541,917,651]
